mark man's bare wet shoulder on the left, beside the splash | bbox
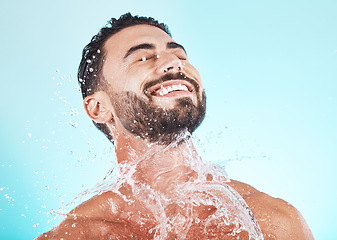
[37,189,155,240]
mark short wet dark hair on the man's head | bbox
[77,13,171,142]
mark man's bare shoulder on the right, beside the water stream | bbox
[227,180,314,240]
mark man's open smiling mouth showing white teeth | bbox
[146,80,194,97]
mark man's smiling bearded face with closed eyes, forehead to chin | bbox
[103,25,206,144]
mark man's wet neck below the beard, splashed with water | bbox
[115,127,205,192]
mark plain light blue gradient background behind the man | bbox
[0,0,337,240]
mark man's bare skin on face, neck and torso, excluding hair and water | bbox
[37,25,313,240]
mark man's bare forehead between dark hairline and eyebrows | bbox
[104,25,173,55]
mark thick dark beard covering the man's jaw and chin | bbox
[111,79,206,145]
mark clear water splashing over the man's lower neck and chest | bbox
[60,132,263,240]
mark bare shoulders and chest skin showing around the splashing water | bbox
[37,180,313,240]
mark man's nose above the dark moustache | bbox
[156,52,182,74]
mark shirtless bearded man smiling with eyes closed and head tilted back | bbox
[38,14,313,240]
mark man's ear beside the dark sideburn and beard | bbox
[83,91,113,123]
